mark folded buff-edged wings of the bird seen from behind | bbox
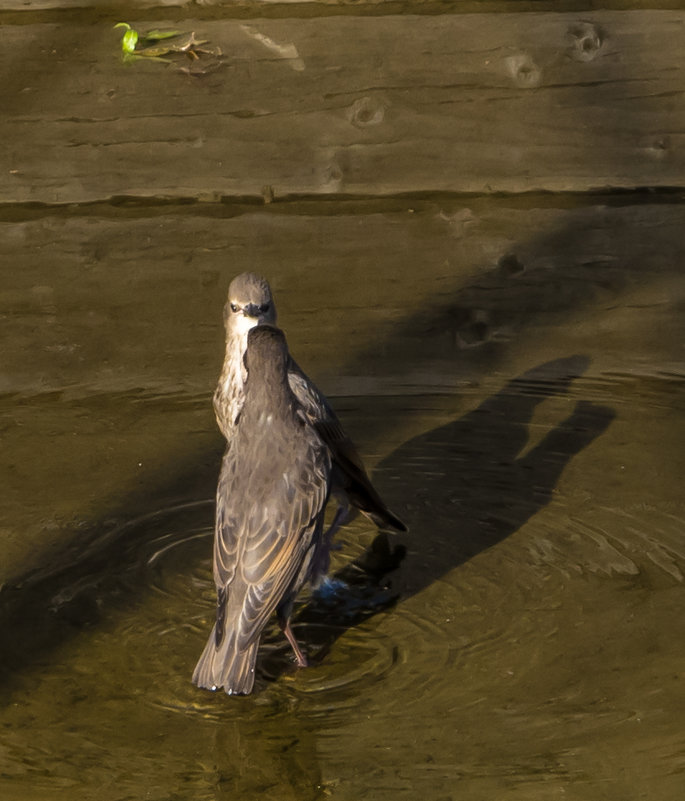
[215,432,330,648]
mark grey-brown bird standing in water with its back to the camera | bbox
[193,324,332,695]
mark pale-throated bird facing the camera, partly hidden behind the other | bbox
[213,272,407,552]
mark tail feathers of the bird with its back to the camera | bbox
[193,625,259,695]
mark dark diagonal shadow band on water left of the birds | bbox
[0,447,222,682]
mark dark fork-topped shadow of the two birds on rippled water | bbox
[286,356,615,672]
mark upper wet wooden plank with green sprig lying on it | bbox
[0,10,685,204]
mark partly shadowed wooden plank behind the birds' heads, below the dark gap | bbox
[0,197,685,396]
